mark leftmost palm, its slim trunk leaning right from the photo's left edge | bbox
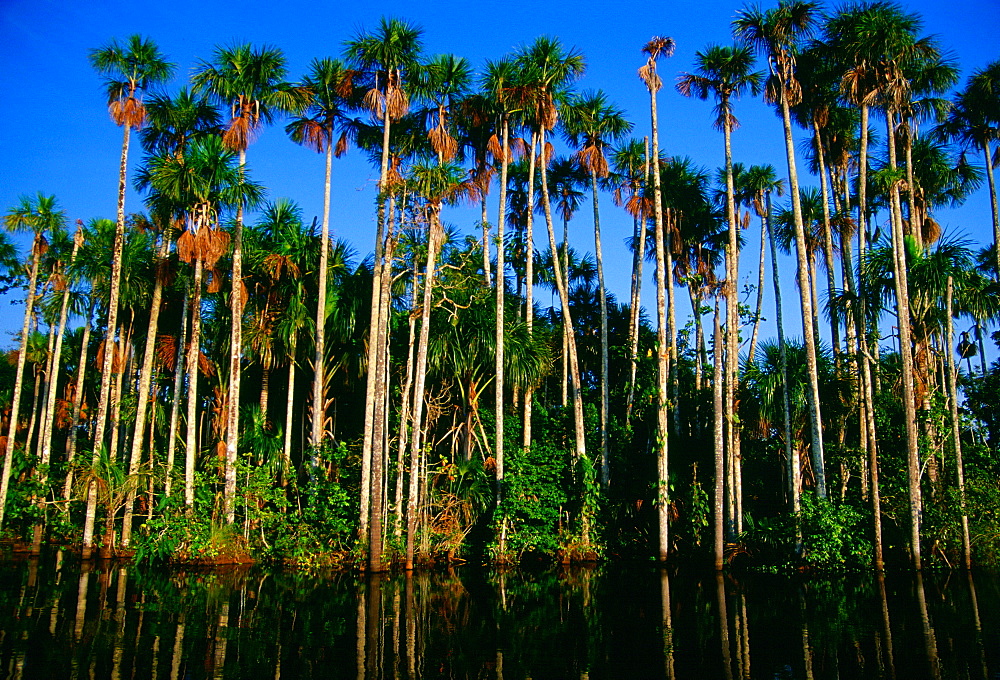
[0,192,66,528]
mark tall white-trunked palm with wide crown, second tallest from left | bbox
[191,44,309,523]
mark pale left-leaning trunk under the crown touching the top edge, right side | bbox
[781,86,826,498]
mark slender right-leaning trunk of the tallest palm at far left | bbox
[84,123,131,560]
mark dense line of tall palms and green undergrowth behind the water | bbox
[0,0,1000,571]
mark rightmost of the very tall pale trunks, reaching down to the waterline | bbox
[886,110,923,571]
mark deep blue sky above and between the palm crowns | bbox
[0,0,1000,362]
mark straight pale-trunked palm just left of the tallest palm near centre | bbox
[285,59,356,447]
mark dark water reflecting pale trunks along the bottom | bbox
[0,558,1000,680]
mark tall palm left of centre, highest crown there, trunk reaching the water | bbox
[345,17,422,571]
